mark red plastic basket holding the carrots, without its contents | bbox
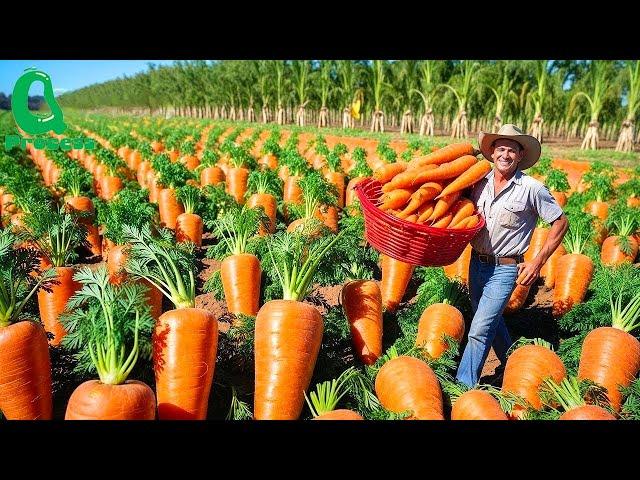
[355,178,485,266]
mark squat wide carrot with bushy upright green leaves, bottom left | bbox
[63,266,156,420]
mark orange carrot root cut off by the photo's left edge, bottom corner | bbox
[0,321,53,420]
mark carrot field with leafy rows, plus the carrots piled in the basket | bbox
[0,105,640,420]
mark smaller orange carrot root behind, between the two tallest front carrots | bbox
[220,253,262,316]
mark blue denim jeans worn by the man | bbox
[456,256,518,387]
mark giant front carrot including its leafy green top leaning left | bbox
[124,225,218,420]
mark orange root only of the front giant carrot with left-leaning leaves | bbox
[153,308,218,420]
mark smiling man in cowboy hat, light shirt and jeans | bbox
[456,124,568,387]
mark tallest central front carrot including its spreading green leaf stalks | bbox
[254,230,346,420]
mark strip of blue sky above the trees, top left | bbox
[0,60,173,96]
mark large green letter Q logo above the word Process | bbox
[11,69,67,135]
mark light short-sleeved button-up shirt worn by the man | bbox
[471,170,563,257]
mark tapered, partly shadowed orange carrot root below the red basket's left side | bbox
[341,280,382,365]
